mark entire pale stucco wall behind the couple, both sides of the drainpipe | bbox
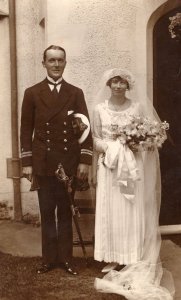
[0,0,175,217]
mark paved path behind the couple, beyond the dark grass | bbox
[0,220,181,300]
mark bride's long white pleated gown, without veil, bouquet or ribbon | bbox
[94,101,144,265]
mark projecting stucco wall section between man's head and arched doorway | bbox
[46,0,170,113]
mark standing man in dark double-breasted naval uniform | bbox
[21,45,92,275]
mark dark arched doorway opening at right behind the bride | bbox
[153,6,181,225]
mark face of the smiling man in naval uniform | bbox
[42,49,66,81]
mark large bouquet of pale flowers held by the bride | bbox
[111,116,169,151]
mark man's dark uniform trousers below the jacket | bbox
[38,176,73,264]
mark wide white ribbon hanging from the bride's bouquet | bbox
[104,139,140,203]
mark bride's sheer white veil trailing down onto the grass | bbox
[93,68,175,300]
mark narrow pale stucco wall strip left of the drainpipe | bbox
[0,0,13,214]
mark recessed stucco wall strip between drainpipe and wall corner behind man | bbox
[16,0,46,215]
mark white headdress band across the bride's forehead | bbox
[103,68,135,89]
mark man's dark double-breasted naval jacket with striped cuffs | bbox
[20,79,92,176]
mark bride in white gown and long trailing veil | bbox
[93,69,174,300]
